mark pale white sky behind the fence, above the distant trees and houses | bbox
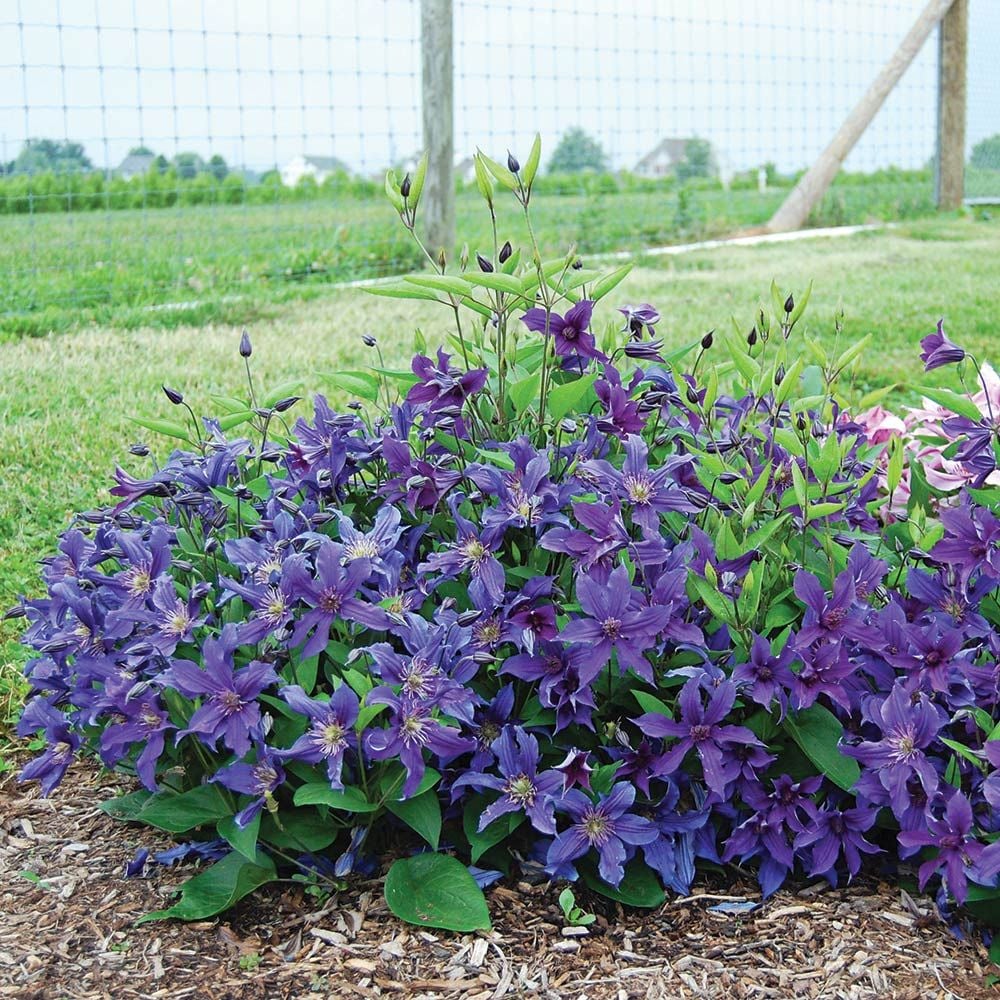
[0,0,1000,172]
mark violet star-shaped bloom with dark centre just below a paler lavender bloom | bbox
[285,536,389,658]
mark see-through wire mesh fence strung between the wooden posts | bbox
[0,0,1000,331]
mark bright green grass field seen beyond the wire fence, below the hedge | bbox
[0,178,933,341]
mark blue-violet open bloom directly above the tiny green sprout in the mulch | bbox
[545,781,659,887]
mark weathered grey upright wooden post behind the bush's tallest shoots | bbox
[420,0,455,256]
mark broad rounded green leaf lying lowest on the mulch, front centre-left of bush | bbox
[384,854,490,932]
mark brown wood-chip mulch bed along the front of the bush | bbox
[0,765,1000,1000]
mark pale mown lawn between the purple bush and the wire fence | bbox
[0,207,1000,664]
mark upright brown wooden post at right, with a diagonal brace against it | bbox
[935,0,969,211]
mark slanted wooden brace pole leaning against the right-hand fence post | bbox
[764,0,953,233]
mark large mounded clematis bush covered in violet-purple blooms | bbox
[15,141,1000,929]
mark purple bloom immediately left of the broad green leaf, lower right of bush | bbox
[633,677,761,797]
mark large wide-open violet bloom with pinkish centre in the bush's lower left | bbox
[161,625,279,757]
